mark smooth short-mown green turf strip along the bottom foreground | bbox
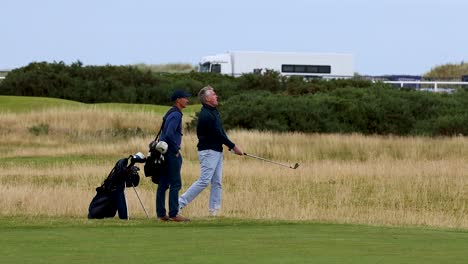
[0,217,468,264]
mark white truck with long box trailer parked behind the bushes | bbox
[199,51,354,79]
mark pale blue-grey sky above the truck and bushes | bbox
[0,0,468,75]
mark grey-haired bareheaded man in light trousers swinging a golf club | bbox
[179,86,243,216]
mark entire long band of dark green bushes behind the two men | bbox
[0,61,468,136]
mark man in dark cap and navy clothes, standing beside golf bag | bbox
[156,90,191,222]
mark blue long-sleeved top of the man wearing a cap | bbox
[159,106,182,153]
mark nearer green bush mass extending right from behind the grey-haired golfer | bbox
[220,85,468,135]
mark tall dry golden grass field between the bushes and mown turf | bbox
[0,109,468,229]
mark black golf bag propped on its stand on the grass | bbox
[88,156,140,219]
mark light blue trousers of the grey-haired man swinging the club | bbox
[179,150,223,214]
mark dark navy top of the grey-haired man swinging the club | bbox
[197,104,235,152]
